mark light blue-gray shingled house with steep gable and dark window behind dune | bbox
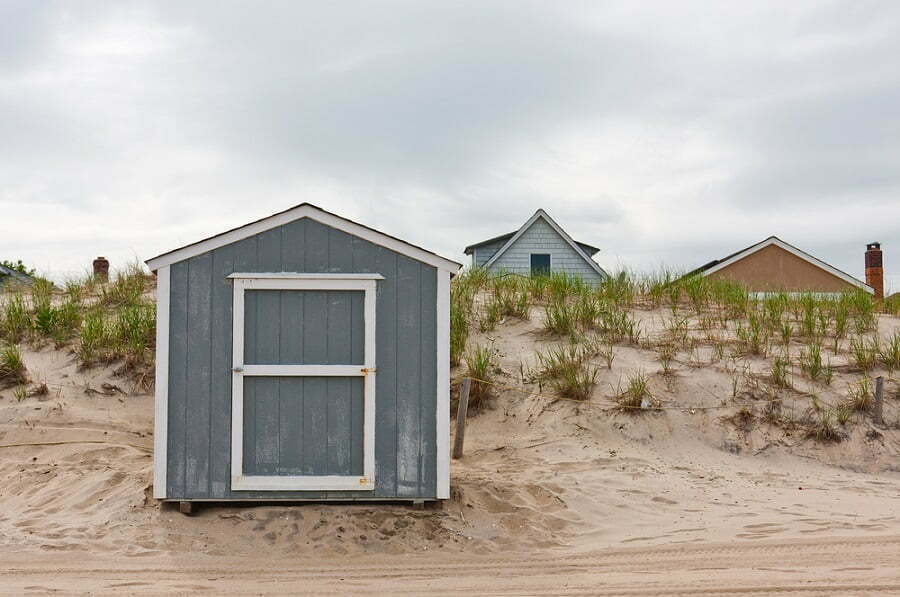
[465,209,609,283]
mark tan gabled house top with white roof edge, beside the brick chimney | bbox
[688,236,874,293]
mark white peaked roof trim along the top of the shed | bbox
[146,203,462,274]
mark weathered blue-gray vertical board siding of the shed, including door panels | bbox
[167,219,440,500]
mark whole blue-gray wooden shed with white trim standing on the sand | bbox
[147,203,461,502]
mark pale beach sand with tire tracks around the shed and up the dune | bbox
[0,309,900,595]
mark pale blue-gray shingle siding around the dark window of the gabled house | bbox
[475,218,603,282]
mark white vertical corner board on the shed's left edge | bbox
[153,265,171,500]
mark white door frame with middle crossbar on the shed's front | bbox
[229,273,383,491]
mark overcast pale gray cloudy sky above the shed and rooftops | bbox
[0,0,900,290]
